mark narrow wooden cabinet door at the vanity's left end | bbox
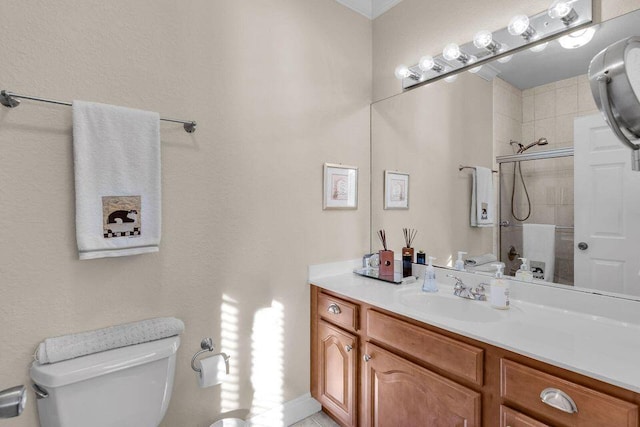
[317,320,358,426]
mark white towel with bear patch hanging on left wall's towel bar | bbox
[73,101,161,259]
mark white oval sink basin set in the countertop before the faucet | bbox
[399,289,502,323]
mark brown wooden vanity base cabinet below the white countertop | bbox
[311,286,640,427]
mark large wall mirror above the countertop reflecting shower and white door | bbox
[371,6,640,299]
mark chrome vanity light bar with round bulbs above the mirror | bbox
[396,0,593,89]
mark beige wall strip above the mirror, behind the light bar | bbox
[373,0,638,100]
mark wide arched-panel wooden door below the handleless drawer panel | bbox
[363,343,481,427]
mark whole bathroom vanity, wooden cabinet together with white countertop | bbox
[310,270,640,427]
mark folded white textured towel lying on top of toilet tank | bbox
[35,317,184,364]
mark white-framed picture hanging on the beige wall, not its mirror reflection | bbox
[322,163,358,209]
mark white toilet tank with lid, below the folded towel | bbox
[30,336,180,427]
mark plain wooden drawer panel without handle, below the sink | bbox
[367,310,484,385]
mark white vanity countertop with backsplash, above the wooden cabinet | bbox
[309,262,640,392]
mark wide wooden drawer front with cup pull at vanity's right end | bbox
[500,359,638,427]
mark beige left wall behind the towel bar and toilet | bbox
[0,0,371,427]
